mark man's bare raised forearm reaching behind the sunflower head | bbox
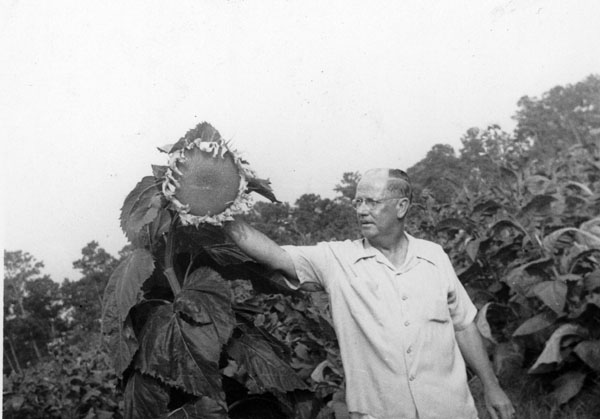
[224,220,298,285]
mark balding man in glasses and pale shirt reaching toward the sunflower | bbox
[226,169,514,419]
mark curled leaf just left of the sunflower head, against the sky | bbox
[121,176,163,243]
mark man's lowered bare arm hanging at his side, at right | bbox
[455,322,515,419]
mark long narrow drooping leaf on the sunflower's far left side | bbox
[102,249,154,375]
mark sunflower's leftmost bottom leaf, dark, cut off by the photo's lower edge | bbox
[123,371,169,419]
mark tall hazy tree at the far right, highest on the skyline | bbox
[514,75,600,159]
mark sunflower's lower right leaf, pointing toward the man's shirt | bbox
[227,328,308,392]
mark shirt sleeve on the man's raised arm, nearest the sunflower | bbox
[281,243,330,289]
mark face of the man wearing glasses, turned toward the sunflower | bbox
[356,175,405,242]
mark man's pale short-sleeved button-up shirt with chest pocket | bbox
[284,236,477,419]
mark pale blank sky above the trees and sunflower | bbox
[0,0,600,281]
